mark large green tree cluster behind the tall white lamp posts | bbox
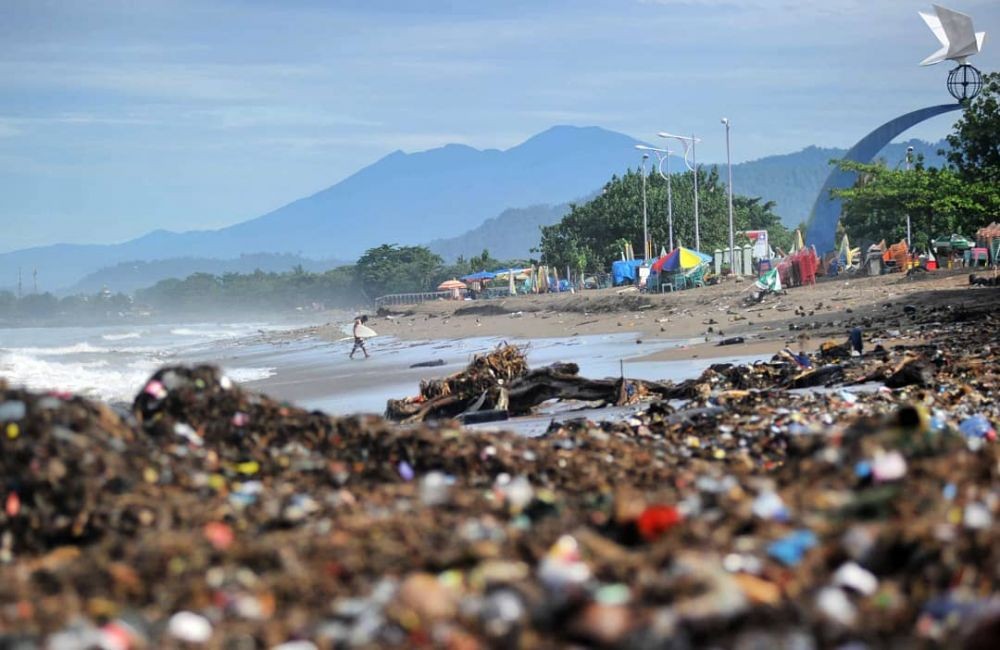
[539,167,791,271]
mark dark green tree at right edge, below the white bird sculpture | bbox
[948,72,1000,185]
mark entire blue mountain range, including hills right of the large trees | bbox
[0,126,940,292]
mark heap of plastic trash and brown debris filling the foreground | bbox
[0,302,1000,650]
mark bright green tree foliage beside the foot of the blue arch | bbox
[833,161,1000,248]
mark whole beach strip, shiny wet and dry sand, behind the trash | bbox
[238,272,975,414]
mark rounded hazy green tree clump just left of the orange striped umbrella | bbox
[356,244,444,298]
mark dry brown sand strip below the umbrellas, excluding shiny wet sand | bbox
[312,271,975,361]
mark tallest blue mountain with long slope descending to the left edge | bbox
[0,126,638,290]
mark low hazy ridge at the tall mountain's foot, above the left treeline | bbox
[65,253,349,294]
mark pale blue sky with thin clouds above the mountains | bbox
[0,0,1000,252]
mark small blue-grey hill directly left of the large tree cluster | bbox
[427,203,570,262]
